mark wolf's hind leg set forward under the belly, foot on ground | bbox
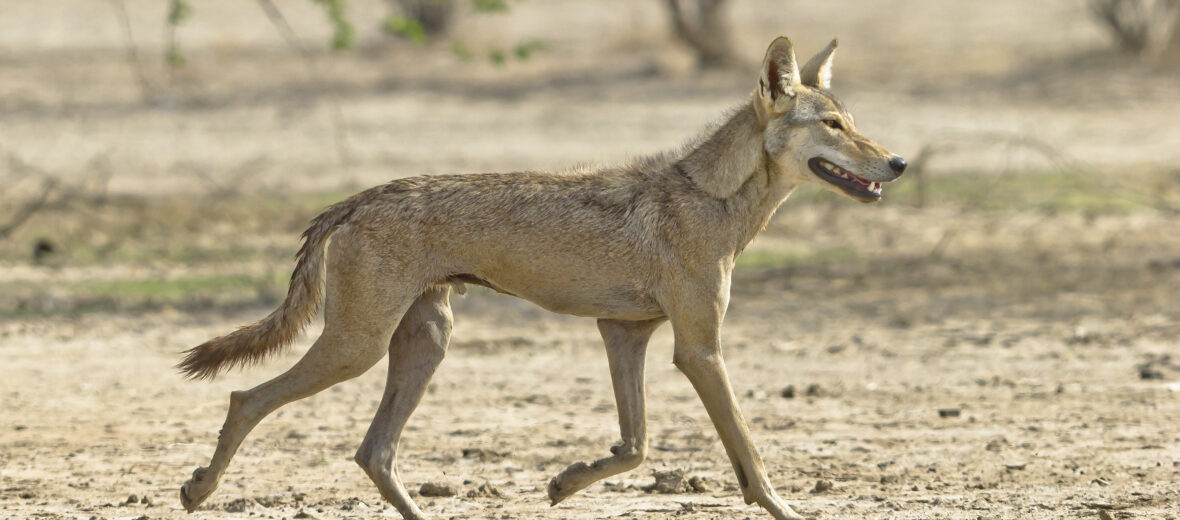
[354,287,452,520]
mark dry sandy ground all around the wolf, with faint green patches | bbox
[0,0,1180,519]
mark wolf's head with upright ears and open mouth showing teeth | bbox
[754,37,905,203]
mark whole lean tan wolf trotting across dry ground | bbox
[178,38,906,520]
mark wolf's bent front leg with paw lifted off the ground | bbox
[549,320,663,505]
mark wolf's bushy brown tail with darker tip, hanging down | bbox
[176,199,355,380]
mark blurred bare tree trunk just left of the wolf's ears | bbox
[664,0,735,68]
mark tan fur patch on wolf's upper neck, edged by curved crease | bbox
[677,104,765,199]
